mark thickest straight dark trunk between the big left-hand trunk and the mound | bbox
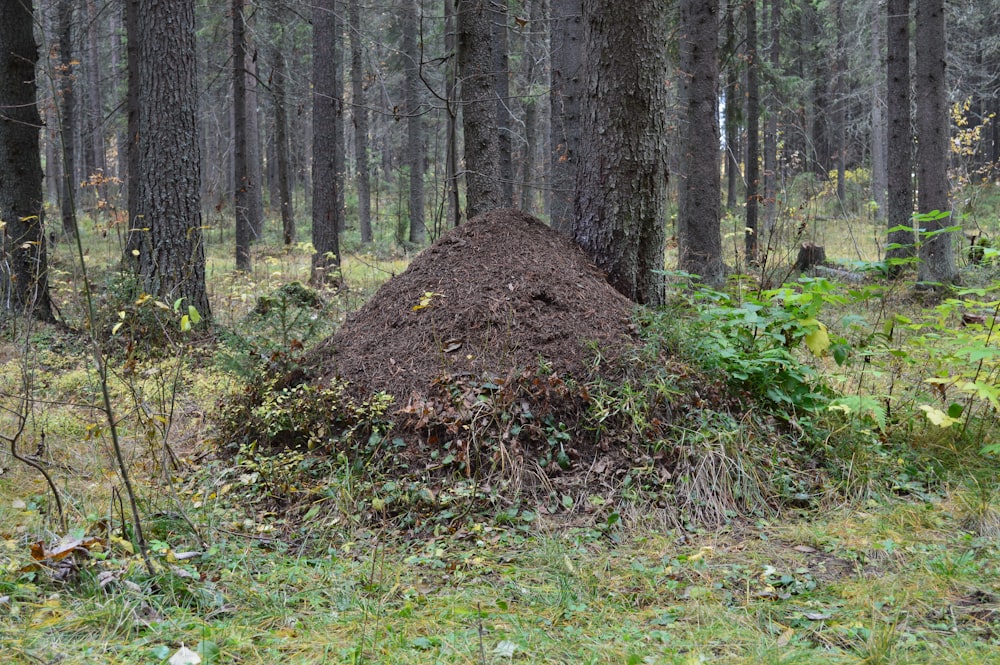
[311,0,344,284]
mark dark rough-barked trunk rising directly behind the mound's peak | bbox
[456,0,503,219]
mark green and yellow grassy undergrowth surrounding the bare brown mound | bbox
[0,176,1000,663]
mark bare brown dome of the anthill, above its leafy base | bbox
[306,209,632,408]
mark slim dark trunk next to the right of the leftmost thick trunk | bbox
[58,0,79,237]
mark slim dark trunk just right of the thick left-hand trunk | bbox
[232,0,254,272]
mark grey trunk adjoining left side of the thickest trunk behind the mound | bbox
[549,0,584,233]
